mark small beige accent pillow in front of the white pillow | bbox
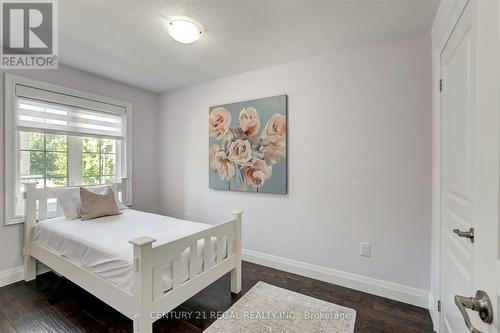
[80,186,121,221]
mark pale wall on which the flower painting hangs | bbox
[158,33,431,290]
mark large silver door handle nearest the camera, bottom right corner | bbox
[455,290,493,333]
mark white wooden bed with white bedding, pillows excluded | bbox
[23,179,242,333]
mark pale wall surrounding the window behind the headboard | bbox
[0,66,159,275]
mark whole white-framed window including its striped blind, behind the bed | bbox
[5,74,130,224]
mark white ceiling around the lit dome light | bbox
[59,0,439,92]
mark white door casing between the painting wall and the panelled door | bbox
[429,0,469,332]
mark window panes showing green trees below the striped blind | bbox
[15,131,120,216]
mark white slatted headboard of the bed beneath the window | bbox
[24,178,128,225]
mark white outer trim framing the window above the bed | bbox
[4,73,132,225]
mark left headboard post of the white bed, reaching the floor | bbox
[23,183,36,281]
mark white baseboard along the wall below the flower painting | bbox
[242,249,429,309]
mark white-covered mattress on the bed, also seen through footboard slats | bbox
[32,209,226,293]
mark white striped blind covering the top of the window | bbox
[16,85,126,140]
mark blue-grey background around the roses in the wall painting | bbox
[208,95,288,193]
